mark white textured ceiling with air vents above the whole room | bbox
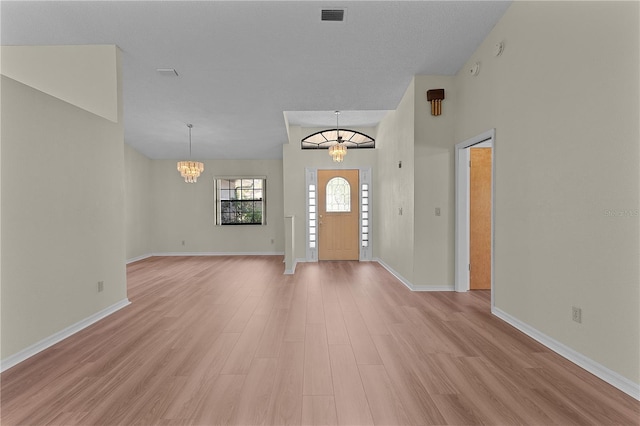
[0,0,510,159]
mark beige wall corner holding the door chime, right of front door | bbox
[374,76,456,290]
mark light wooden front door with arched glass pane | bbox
[318,170,360,260]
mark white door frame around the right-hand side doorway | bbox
[454,129,496,302]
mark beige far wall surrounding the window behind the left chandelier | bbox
[148,160,284,254]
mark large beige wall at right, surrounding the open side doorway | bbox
[456,2,640,383]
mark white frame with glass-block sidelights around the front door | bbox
[304,167,375,262]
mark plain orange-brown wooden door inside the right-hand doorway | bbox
[469,148,491,290]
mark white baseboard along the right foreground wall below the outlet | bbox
[491,307,640,400]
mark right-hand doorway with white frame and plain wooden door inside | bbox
[455,129,495,300]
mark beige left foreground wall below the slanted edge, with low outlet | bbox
[0,46,127,359]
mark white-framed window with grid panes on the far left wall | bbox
[215,177,267,225]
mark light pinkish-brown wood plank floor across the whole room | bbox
[0,256,640,425]
